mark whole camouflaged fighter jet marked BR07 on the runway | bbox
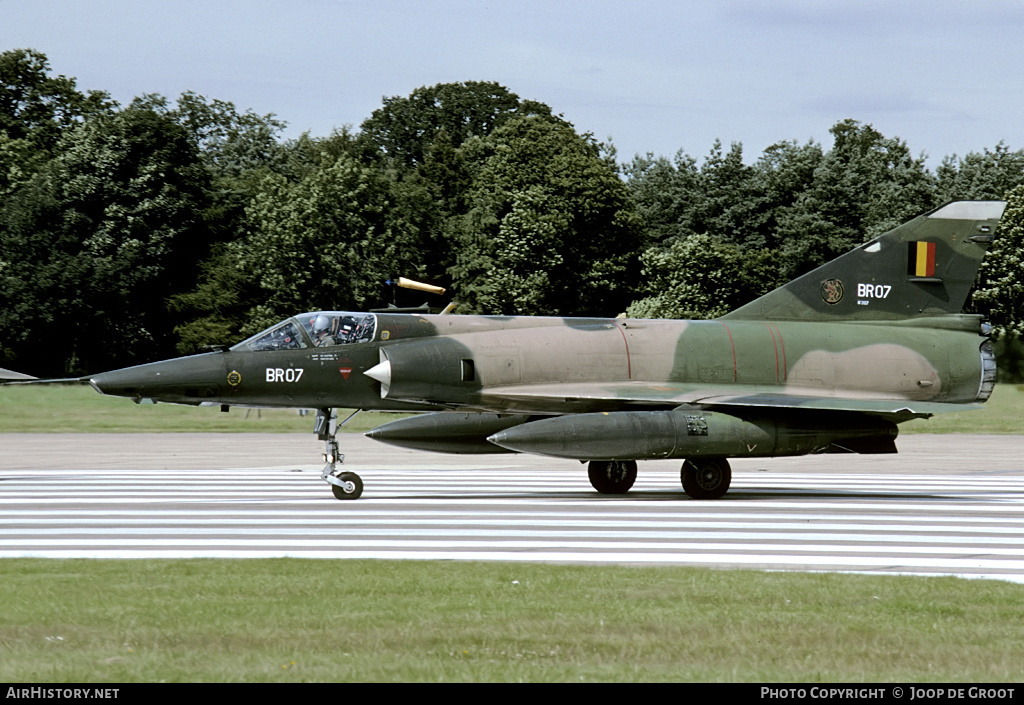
[48,201,1006,499]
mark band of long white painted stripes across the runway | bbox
[0,464,1024,582]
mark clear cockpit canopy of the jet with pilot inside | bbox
[231,310,377,351]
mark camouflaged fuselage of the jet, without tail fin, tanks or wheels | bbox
[92,312,991,414]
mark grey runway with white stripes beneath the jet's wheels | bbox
[0,434,1024,582]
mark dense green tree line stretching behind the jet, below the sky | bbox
[0,50,1024,375]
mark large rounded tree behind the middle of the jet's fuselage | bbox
[452,117,640,316]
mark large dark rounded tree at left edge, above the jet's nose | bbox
[0,101,209,373]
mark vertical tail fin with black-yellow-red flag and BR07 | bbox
[723,201,1007,321]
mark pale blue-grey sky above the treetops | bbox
[0,0,1024,167]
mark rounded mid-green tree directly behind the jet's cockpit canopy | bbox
[229,147,430,334]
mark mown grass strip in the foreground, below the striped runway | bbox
[0,558,1024,682]
